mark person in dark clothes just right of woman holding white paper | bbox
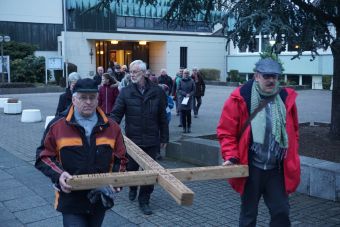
[191,68,205,118]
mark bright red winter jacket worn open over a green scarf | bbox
[217,81,300,194]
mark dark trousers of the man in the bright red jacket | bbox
[240,166,290,227]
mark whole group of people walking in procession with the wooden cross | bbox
[35,59,300,226]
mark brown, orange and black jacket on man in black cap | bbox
[35,105,127,213]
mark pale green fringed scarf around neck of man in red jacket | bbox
[250,81,288,156]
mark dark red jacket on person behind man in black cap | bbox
[98,84,119,115]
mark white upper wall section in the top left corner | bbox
[0,0,63,24]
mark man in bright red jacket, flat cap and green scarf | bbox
[217,58,300,227]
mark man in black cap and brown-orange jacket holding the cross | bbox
[35,78,127,226]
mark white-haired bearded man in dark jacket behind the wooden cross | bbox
[111,60,169,215]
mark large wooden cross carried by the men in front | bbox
[68,136,248,206]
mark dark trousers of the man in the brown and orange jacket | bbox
[63,211,105,227]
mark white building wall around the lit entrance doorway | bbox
[60,32,226,78]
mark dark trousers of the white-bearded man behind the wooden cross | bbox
[126,145,160,204]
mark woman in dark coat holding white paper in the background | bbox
[178,69,195,133]
